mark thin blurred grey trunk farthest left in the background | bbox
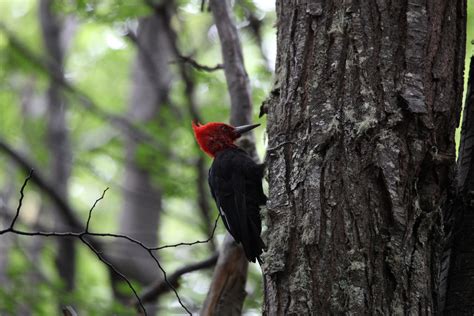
[39,0,76,291]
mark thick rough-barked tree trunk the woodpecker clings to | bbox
[264,0,466,315]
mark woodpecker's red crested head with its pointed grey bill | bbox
[193,121,260,157]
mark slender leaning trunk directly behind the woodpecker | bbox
[201,0,258,315]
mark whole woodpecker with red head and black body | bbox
[192,122,267,264]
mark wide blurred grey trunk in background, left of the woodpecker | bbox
[112,15,171,285]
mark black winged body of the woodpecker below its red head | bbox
[209,149,266,261]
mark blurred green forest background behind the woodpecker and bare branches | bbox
[0,0,275,315]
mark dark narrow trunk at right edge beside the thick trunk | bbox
[444,57,474,315]
